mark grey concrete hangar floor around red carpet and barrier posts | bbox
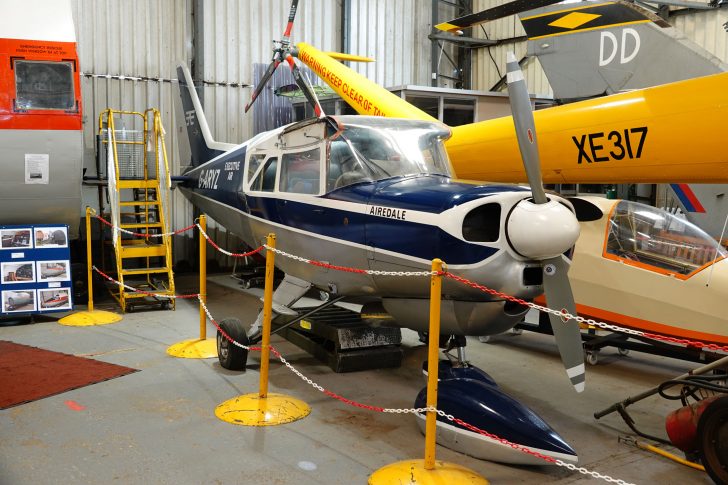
[0,276,712,485]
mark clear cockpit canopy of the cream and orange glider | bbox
[604,200,726,279]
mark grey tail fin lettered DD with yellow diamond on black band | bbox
[520,1,728,101]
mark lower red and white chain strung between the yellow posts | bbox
[92,266,632,485]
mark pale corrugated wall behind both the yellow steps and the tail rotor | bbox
[73,0,341,264]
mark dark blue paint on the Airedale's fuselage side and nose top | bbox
[183,174,516,265]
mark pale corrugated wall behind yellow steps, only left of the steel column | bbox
[73,0,191,260]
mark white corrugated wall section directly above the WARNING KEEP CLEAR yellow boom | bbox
[349,0,432,87]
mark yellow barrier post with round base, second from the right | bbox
[215,234,311,426]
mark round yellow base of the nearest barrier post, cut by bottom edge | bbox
[368,460,490,485]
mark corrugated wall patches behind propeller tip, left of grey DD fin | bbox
[472,0,552,96]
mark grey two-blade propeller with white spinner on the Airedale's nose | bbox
[507,52,586,392]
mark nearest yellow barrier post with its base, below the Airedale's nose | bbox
[368,259,489,485]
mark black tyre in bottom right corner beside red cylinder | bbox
[698,396,728,483]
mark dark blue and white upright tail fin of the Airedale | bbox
[175,64,235,171]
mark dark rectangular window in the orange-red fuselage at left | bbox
[13,59,76,110]
